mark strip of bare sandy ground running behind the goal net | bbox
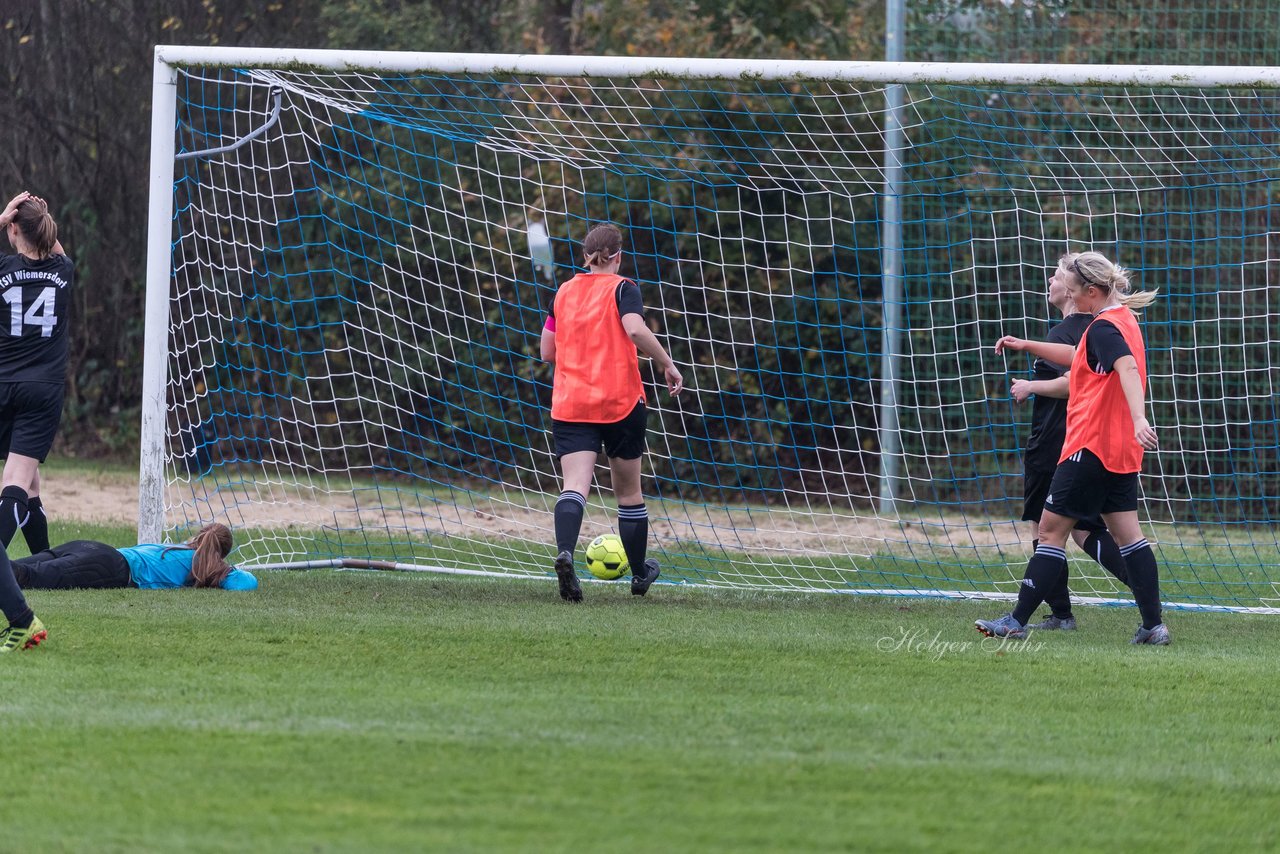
[42,474,1021,557]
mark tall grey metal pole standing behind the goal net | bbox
[879,0,905,516]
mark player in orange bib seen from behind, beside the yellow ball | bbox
[541,224,685,602]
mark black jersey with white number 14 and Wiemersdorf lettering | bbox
[0,252,76,383]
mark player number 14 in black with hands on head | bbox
[0,192,76,553]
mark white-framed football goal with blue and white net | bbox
[140,47,1280,609]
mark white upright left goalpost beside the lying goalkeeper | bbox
[138,50,178,543]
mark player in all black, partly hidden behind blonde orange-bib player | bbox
[1010,265,1128,631]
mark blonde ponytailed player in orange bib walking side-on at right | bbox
[974,252,1170,645]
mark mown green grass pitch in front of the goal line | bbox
[0,526,1280,851]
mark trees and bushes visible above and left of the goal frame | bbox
[0,0,1280,468]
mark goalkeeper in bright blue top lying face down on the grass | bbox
[13,524,257,590]
